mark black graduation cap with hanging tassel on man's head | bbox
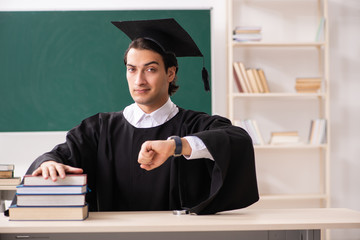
[112,18,210,91]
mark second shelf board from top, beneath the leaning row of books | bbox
[233,93,325,98]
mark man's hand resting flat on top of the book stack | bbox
[32,161,83,182]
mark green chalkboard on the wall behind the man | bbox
[0,10,211,132]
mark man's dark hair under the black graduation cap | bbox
[124,38,179,96]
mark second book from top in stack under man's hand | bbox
[16,184,87,194]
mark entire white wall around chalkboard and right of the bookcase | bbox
[0,0,360,239]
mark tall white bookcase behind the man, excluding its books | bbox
[227,0,330,208]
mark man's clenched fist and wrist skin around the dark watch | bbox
[138,138,191,171]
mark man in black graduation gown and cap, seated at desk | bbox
[28,19,259,214]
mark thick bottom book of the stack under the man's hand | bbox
[9,204,89,221]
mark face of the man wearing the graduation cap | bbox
[126,48,175,113]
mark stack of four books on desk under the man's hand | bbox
[9,174,88,220]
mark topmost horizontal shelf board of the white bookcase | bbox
[232,41,325,48]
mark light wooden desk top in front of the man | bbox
[0,208,360,233]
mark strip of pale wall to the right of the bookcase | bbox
[329,0,360,239]
